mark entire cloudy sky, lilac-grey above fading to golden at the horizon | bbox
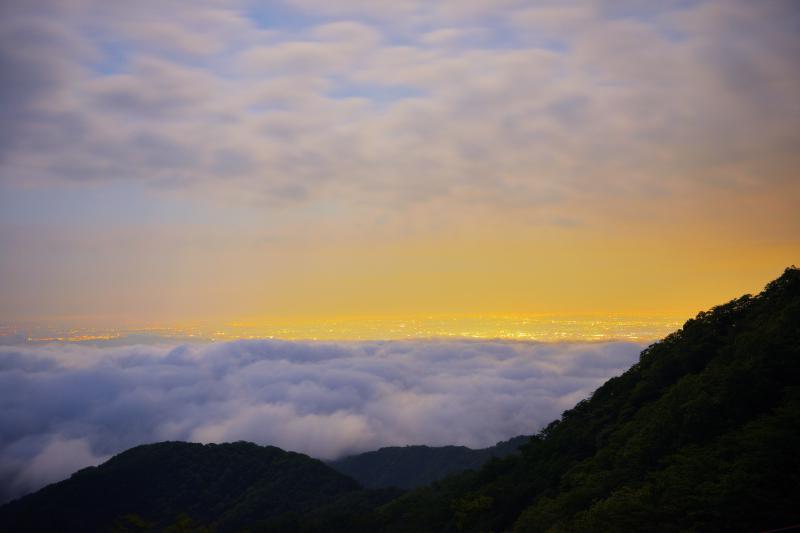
[0,0,800,328]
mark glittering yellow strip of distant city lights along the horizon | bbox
[0,314,685,343]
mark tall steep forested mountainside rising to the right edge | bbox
[379,268,800,532]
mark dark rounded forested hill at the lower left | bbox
[0,442,368,531]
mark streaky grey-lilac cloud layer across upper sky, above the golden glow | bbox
[0,0,800,211]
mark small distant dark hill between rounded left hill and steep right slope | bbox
[328,436,530,489]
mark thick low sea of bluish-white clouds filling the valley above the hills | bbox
[0,340,641,500]
